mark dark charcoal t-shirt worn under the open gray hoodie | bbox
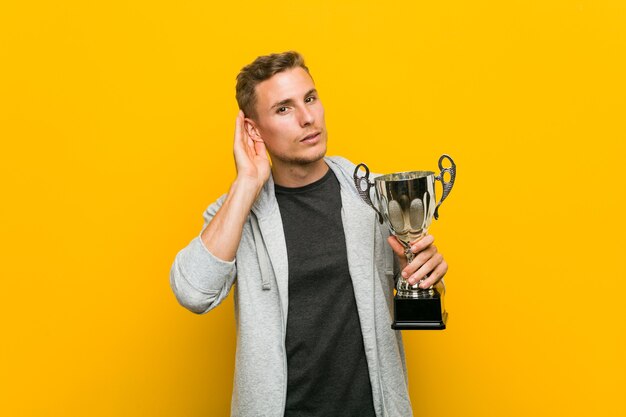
[275,169,375,417]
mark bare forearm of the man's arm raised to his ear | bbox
[200,177,260,261]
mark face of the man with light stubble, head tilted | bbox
[248,67,327,165]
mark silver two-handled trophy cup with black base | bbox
[354,155,456,330]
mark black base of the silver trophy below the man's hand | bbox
[391,288,448,330]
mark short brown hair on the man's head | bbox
[235,51,310,118]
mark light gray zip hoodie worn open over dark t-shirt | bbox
[170,157,413,417]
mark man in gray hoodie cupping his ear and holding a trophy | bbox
[171,52,447,417]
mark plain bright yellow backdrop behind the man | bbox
[0,0,626,417]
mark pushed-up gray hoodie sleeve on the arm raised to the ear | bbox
[170,195,236,314]
